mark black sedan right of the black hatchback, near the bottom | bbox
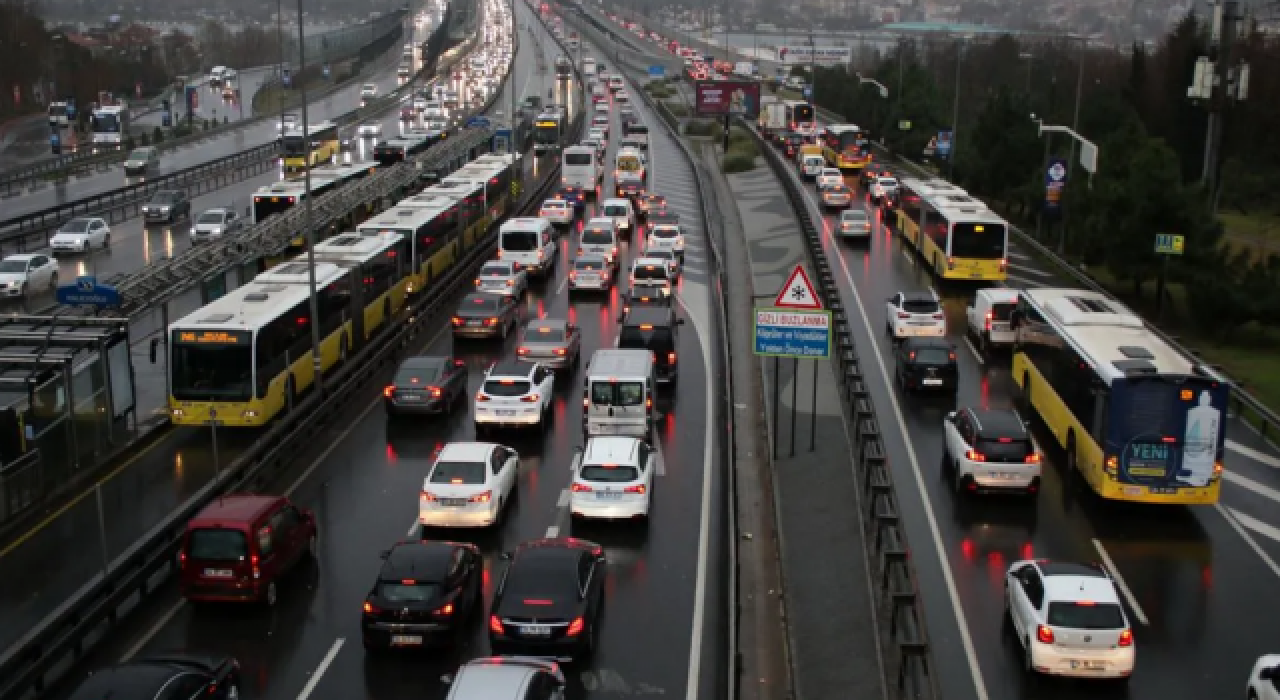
[489,537,605,660]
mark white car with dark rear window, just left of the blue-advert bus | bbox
[942,407,1041,495]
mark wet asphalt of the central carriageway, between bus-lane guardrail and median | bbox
[15,4,724,700]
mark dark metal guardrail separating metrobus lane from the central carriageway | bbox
[0,21,565,700]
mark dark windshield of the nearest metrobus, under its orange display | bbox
[170,331,253,401]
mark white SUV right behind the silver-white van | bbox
[568,438,658,521]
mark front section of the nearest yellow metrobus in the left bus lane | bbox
[169,262,356,427]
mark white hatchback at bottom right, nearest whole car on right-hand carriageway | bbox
[1005,559,1134,678]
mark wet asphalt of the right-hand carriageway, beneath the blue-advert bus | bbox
[773,139,1280,700]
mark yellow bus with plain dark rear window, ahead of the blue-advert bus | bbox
[896,178,1009,282]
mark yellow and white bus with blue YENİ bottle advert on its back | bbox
[1010,289,1230,504]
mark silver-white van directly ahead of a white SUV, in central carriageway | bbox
[582,348,657,440]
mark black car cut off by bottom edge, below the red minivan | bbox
[70,653,241,700]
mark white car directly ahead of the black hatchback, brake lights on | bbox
[417,443,520,527]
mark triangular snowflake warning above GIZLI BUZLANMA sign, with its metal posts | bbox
[754,265,832,458]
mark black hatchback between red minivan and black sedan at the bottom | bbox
[360,541,484,652]
